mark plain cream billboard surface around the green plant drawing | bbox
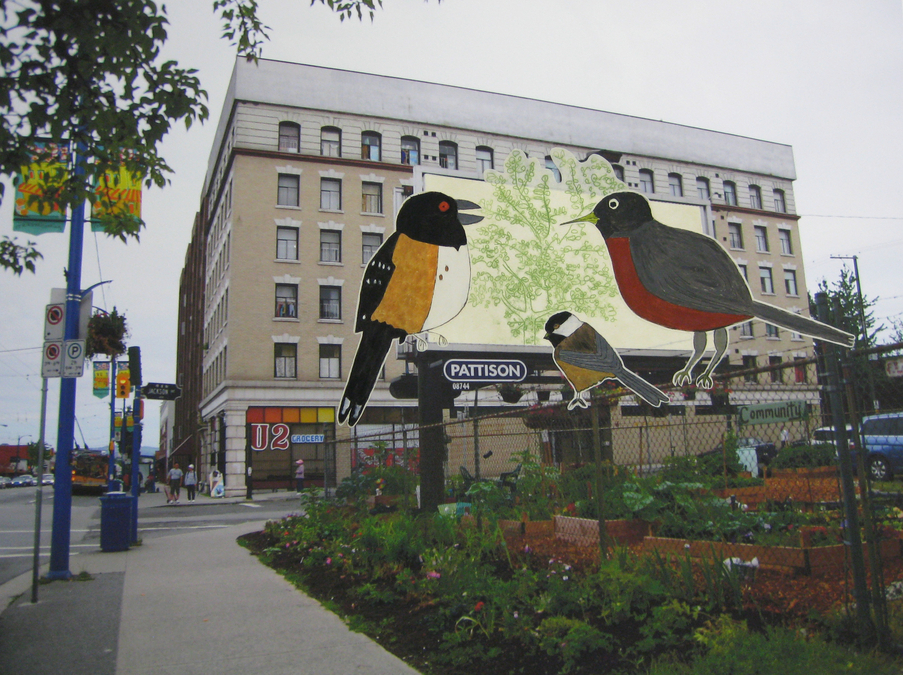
[423,149,702,354]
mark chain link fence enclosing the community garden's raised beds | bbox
[332,345,903,640]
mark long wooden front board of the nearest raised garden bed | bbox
[643,537,903,574]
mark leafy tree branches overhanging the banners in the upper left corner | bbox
[0,0,208,270]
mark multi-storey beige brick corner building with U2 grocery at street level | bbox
[175,60,811,495]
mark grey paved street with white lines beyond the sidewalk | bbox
[0,487,298,584]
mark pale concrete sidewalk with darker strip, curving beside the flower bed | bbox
[0,492,417,675]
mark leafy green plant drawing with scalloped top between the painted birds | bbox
[469,148,625,345]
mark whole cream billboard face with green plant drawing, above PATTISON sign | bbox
[423,149,704,353]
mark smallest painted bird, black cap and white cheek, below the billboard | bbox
[543,312,668,410]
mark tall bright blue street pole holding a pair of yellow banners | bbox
[47,140,85,580]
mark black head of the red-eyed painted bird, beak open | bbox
[395,192,483,248]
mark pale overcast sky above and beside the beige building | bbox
[0,0,903,454]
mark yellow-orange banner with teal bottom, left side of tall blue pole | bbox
[13,141,69,235]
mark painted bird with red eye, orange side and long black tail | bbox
[338,192,483,426]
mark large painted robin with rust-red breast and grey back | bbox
[563,192,853,389]
